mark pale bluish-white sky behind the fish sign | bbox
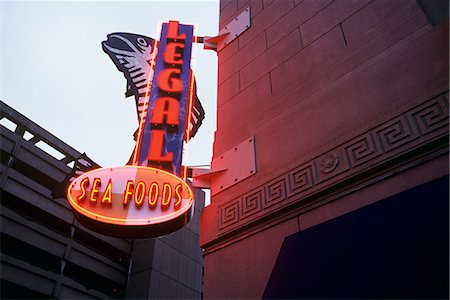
[0,0,219,195]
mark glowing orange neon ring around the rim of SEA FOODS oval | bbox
[67,166,194,226]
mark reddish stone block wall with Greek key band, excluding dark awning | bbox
[201,0,448,298]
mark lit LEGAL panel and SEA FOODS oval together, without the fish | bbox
[67,21,194,238]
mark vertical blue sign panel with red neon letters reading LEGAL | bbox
[135,21,194,176]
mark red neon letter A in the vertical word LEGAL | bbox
[150,97,180,126]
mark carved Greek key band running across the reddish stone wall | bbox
[219,92,449,235]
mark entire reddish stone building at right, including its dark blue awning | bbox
[200,0,449,299]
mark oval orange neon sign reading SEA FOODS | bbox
[67,166,194,238]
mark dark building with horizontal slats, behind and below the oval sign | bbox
[0,102,204,299]
